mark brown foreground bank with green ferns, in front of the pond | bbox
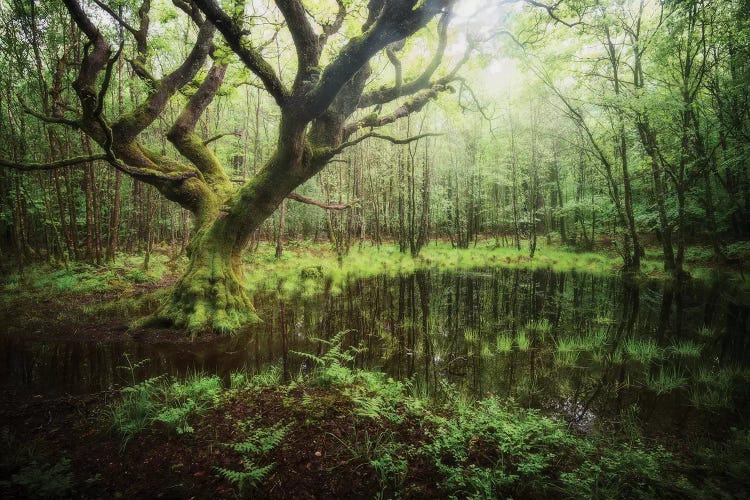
[0,357,750,498]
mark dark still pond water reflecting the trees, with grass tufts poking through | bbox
[0,270,750,432]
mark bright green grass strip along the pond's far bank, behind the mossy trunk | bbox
[2,240,748,308]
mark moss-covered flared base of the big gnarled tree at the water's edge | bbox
[137,259,259,335]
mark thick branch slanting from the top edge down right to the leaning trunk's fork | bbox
[194,0,289,106]
